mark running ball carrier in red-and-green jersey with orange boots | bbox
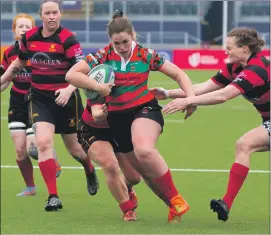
[66,9,198,222]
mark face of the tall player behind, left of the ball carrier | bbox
[41,2,61,32]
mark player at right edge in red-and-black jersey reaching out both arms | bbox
[157,28,270,221]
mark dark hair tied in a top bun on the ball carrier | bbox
[107,10,135,37]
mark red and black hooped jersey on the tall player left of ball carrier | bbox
[19,27,83,91]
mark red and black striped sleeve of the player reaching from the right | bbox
[232,65,268,94]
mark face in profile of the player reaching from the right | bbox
[226,37,248,63]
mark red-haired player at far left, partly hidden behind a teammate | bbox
[1,13,61,196]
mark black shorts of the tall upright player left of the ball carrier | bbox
[28,89,84,134]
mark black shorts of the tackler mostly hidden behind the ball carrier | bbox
[77,120,119,154]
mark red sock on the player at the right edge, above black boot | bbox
[223,163,249,209]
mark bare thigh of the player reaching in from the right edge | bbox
[237,122,270,152]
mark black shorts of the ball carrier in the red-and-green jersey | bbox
[107,100,164,153]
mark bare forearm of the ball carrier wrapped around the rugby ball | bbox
[66,72,99,91]
